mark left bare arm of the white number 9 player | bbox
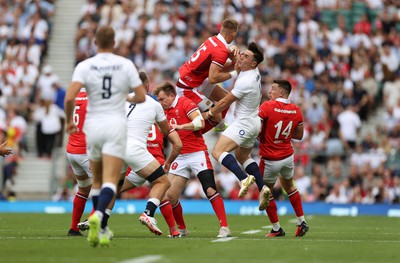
[64,81,83,134]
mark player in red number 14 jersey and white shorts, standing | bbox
[258,80,309,237]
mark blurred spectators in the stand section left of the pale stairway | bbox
[0,0,65,198]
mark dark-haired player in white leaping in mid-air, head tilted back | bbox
[204,42,271,208]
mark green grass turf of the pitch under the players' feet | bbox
[0,214,400,263]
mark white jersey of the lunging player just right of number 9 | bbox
[125,95,167,145]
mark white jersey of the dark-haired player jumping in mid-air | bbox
[231,68,261,119]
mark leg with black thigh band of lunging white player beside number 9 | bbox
[137,159,170,235]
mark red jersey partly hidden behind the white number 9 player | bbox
[67,88,87,154]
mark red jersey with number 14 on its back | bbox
[259,99,303,160]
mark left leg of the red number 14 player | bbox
[260,159,285,237]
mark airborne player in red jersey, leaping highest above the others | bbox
[176,18,239,133]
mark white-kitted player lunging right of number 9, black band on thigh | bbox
[122,72,182,235]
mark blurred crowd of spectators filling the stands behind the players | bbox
[0,0,400,204]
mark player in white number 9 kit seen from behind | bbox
[65,26,145,246]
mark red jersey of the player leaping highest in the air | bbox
[179,35,229,88]
